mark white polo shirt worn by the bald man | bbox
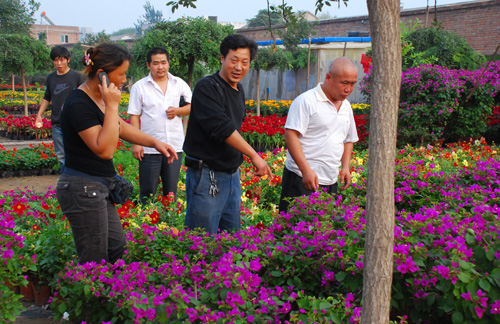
[285,83,358,186]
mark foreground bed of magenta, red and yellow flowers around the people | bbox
[0,140,500,323]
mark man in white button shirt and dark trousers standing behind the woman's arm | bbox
[128,47,192,204]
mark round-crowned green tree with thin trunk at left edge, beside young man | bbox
[0,34,49,116]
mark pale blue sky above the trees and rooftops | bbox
[35,0,473,34]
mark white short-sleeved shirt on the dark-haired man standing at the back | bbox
[127,73,192,154]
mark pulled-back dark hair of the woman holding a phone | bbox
[82,43,132,78]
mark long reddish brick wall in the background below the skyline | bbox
[237,0,500,55]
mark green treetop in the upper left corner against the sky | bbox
[0,0,40,35]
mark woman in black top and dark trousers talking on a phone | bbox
[57,44,177,264]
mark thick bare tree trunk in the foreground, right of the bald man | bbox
[361,0,401,324]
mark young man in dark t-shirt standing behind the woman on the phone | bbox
[35,46,85,171]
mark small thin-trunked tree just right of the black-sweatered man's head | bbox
[252,45,292,116]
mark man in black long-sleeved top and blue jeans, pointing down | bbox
[183,35,272,234]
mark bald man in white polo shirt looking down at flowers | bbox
[279,57,358,212]
